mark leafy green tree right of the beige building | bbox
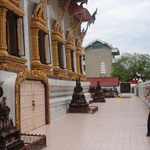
[111,53,150,82]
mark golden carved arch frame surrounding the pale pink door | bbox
[15,69,50,129]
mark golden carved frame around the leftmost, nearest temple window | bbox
[0,0,27,71]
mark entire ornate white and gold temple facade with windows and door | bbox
[0,0,96,132]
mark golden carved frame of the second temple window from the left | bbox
[30,0,53,75]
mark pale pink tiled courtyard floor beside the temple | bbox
[28,97,150,150]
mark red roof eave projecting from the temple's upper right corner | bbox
[70,3,94,23]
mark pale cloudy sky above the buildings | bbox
[83,0,150,55]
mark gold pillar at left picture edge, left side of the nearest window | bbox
[0,7,8,55]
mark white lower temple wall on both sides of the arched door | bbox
[0,71,91,122]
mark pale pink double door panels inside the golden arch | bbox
[20,80,45,133]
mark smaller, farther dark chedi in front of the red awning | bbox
[93,81,106,102]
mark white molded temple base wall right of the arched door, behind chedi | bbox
[49,79,91,119]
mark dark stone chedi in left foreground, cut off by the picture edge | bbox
[0,88,24,150]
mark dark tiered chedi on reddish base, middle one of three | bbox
[68,78,98,113]
